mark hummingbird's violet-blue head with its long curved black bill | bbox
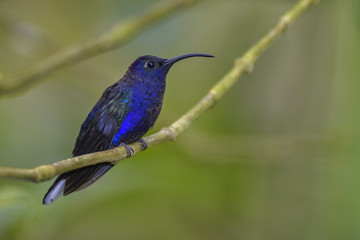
[127,53,213,81]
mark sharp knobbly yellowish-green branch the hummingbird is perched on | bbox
[0,0,317,182]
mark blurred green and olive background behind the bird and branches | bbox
[0,0,360,240]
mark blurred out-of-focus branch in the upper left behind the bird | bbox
[0,0,200,96]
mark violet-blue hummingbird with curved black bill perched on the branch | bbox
[43,53,213,204]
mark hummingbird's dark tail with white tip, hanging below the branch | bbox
[43,163,114,205]
